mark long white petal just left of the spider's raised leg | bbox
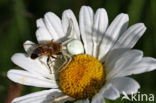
[44,12,65,40]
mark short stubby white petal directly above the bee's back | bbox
[36,28,53,44]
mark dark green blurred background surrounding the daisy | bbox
[0,0,156,103]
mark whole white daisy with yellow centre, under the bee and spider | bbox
[7,6,156,103]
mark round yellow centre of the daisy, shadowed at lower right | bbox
[59,54,105,99]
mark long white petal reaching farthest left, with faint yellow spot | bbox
[7,69,58,88]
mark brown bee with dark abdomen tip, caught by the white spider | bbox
[30,39,72,71]
